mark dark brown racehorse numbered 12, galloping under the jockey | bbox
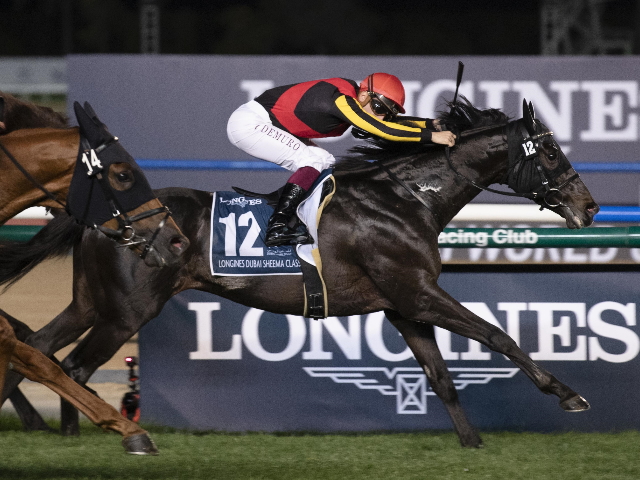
[0,101,599,447]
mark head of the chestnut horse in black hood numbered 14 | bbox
[67,102,189,266]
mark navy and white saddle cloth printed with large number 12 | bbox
[209,170,333,276]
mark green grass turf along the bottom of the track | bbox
[0,416,640,480]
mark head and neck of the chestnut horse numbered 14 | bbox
[0,92,188,266]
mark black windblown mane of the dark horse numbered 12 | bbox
[335,95,510,170]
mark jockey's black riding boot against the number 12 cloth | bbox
[264,183,312,247]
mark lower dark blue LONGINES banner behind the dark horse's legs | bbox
[139,272,640,432]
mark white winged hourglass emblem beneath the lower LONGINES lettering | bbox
[303,367,518,415]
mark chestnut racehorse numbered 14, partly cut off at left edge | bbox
[0,94,189,454]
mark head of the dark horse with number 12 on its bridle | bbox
[509,99,600,228]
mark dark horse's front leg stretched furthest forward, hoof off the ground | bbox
[382,282,589,412]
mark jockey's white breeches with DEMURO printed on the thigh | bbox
[227,100,336,172]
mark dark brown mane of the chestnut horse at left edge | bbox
[0,92,69,134]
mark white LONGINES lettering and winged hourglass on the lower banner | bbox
[188,301,640,414]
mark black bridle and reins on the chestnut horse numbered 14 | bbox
[0,136,171,259]
